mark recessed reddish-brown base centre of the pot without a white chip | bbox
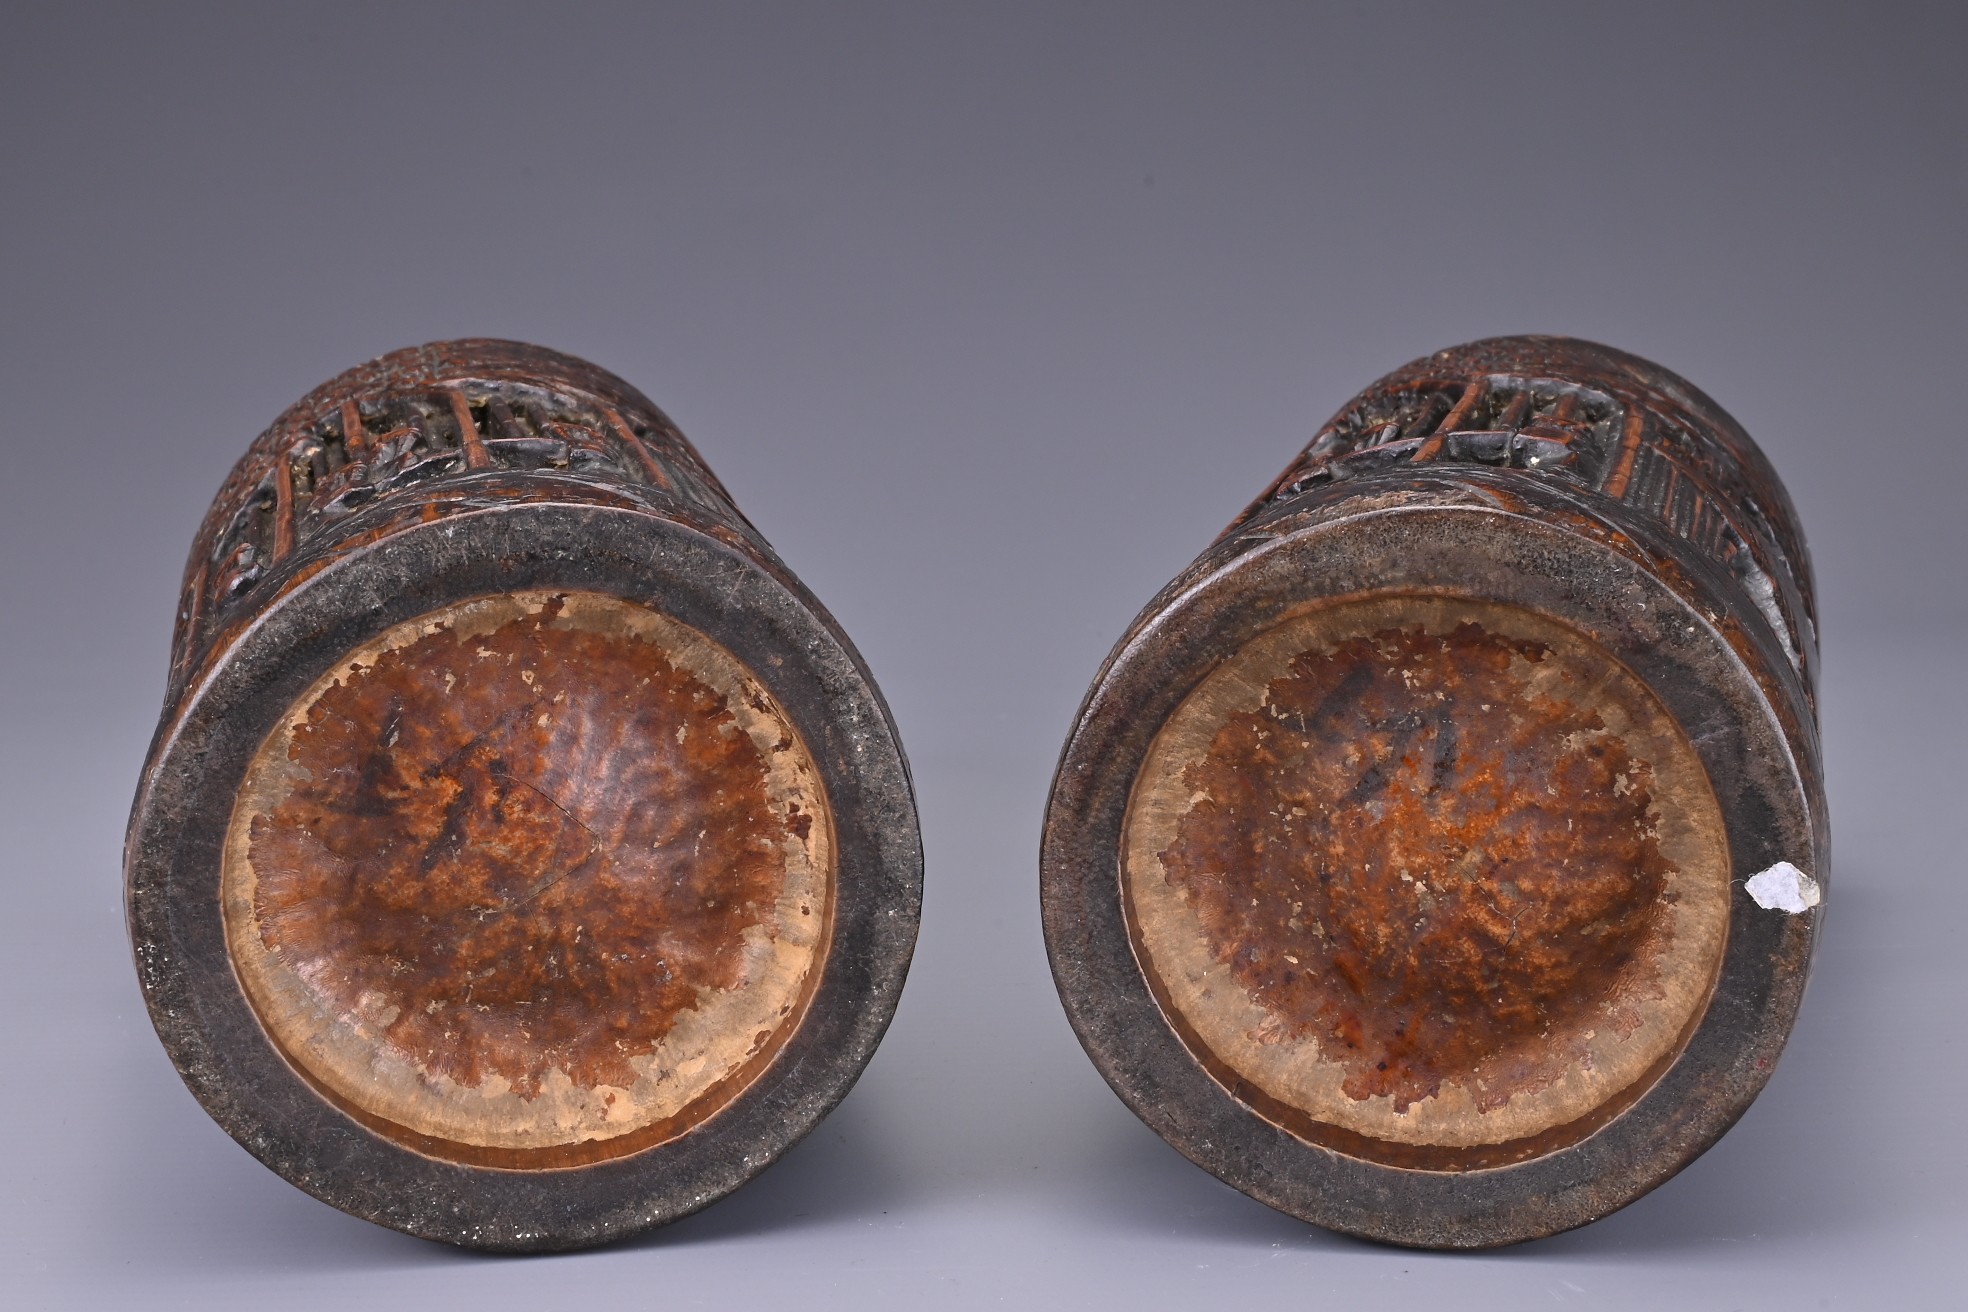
[224,592,832,1166]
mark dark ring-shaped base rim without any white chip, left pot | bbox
[126,502,921,1251]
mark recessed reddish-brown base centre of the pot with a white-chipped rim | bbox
[1126,598,1728,1168]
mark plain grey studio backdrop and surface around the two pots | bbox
[0,2,1968,1308]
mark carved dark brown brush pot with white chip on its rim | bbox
[1043,336,1828,1247]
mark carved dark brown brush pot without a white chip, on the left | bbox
[126,340,921,1249]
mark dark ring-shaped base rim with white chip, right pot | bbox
[1041,480,1826,1247]
